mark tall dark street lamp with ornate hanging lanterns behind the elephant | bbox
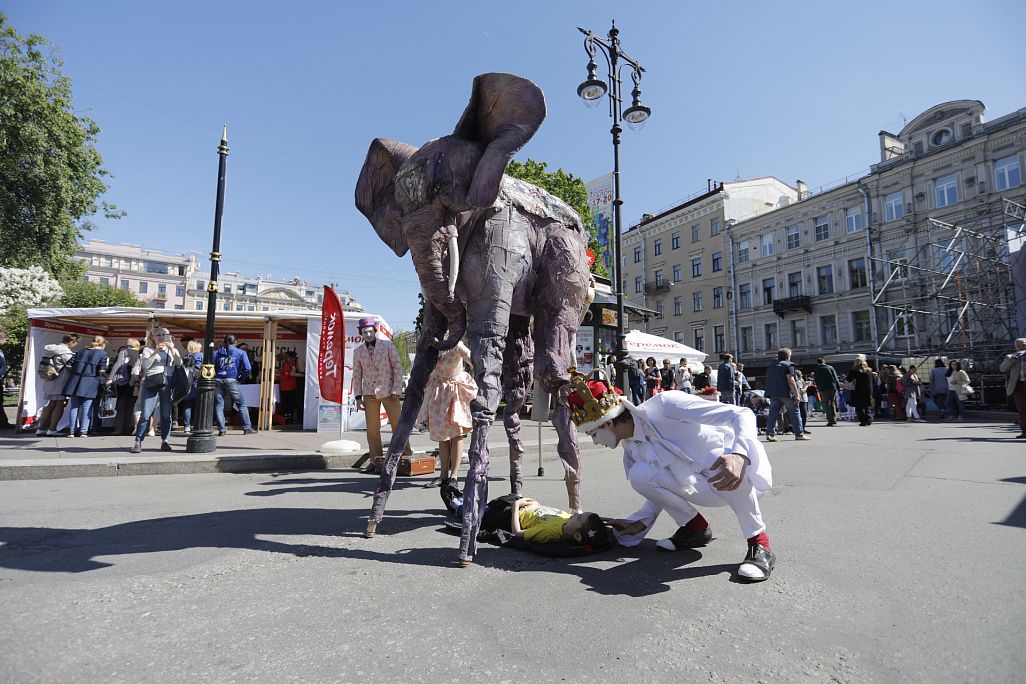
[578,22,652,393]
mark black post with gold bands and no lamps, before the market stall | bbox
[186,125,228,453]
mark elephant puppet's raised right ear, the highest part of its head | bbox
[452,74,545,207]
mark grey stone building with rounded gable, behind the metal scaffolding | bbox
[728,100,1026,373]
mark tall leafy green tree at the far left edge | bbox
[0,13,121,280]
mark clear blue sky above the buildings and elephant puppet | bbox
[8,0,1026,328]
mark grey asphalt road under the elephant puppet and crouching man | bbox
[0,423,1026,683]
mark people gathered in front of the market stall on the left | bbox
[18,327,303,453]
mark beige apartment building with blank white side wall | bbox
[622,177,797,358]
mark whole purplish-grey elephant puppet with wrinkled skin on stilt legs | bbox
[356,74,590,561]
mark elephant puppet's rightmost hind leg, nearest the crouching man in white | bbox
[535,225,589,511]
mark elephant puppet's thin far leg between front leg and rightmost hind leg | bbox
[503,316,535,496]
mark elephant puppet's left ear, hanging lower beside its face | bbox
[356,137,417,256]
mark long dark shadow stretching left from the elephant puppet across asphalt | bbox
[0,509,455,572]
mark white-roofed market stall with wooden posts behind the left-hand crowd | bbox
[17,307,392,430]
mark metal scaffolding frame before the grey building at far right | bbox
[872,200,1026,373]
